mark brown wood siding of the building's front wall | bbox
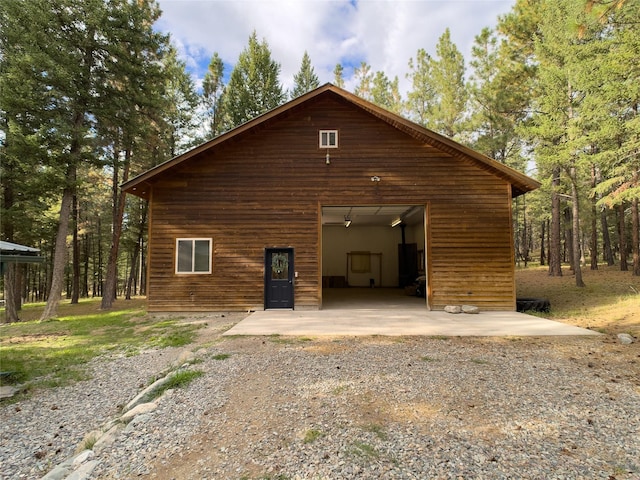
[148,97,515,311]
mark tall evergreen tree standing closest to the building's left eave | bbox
[97,0,170,309]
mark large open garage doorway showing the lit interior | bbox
[322,205,428,309]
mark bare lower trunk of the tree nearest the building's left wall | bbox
[100,147,131,310]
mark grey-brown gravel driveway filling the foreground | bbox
[0,315,640,479]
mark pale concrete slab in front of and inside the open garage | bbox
[224,288,599,337]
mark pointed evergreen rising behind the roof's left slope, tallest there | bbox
[224,31,286,129]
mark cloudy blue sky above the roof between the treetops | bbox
[156,0,515,93]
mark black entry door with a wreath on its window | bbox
[264,248,294,309]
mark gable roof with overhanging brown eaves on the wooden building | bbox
[121,83,540,198]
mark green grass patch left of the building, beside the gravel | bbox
[0,299,200,387]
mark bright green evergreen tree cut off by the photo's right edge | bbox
[580,0,640,275]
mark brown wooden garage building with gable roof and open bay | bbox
[122,84,539,311]
